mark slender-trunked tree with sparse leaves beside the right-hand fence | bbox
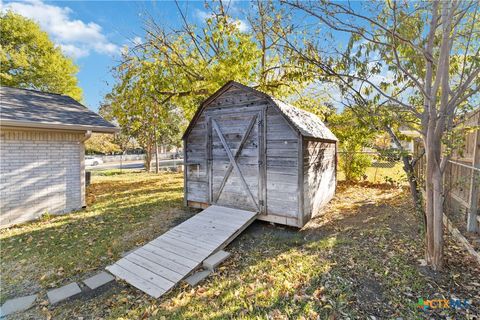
[284,0,480,270]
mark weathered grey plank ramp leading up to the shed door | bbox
[106,206,257,298]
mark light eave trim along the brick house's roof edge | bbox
[0,120,120,133]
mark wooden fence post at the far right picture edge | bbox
[467,120,480,232]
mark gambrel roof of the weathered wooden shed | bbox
[183,81,338,141]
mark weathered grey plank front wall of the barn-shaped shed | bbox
[185,85,299,225]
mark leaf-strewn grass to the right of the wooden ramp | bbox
[142,184,478,319]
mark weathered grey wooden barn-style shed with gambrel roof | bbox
[183,81,337,227]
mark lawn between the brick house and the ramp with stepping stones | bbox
[0,175,193,301]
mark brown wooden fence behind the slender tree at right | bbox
[414,110,480,231]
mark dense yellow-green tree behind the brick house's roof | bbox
[0,11,82,101]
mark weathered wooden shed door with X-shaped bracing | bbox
[206,108,266,213]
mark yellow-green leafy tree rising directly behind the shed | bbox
[109,2,305,172]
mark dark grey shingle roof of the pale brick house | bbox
[0,87,118,132]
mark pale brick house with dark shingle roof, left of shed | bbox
[0,87,117,227]
